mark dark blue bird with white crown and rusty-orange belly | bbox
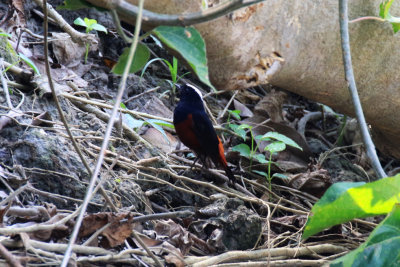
[173,84,236,185]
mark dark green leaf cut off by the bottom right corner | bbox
[330,204,400,267]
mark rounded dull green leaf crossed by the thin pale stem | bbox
[111,43,150,75]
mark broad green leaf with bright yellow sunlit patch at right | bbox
[303,175,400,239]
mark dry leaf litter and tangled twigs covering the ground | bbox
[0,1,394,266]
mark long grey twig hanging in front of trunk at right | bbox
[339,0,386,178]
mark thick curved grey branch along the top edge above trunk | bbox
[86,0,264,27]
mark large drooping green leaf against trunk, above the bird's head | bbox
[152,26,215,90]
